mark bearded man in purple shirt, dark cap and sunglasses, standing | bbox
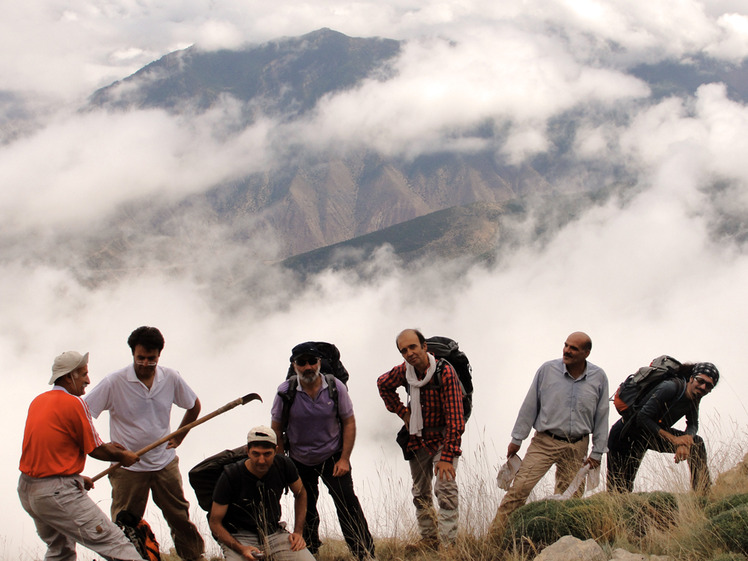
[271,342,374,560]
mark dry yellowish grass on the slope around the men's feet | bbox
[153,426,748,561]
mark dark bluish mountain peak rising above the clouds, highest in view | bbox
[89,28,401,116]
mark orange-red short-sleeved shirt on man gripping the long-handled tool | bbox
[19,386,104,477]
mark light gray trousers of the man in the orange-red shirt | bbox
[18,474,142,561]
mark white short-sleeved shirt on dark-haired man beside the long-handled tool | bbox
[84,364,197,471]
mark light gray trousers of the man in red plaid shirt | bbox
[409,448,459,543]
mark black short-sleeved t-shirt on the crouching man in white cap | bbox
[213,455,299,534]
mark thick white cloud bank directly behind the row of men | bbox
[5,151,748,551]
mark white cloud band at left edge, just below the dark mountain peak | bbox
[0,106,272,229]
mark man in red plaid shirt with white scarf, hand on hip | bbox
[377,329,465,549]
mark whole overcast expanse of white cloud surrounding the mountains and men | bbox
[0,0,748,559]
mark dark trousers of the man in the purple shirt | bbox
[294,452,374,559]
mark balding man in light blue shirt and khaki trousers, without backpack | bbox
[492,331,608,533]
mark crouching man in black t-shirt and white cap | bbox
[210,426,314,561]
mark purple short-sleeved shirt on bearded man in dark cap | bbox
[270,376,353,466]
